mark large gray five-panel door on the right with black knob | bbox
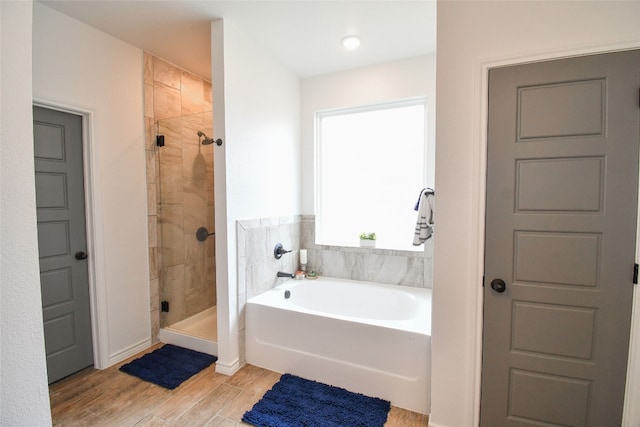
[480,51,640,427]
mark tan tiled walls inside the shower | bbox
[144,52,216,342]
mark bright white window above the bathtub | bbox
[316,98,426,251]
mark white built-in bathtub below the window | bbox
[245,277,431,414]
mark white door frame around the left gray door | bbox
[33,98,109,369]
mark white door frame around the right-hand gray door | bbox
[473,42,640,426]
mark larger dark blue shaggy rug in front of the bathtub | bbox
[242,374,391,427]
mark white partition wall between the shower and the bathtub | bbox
[211,20,301,373]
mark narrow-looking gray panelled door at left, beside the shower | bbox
[33,107,93,383]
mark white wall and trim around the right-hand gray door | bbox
[429,1,640,427]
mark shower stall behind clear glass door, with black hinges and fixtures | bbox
[155,111,217,354]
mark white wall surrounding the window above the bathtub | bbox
[301,55,436,215]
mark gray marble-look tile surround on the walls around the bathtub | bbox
[237,215,433,363]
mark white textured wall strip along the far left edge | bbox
[0,2,51,426]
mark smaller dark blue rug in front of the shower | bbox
[120,344,218,390]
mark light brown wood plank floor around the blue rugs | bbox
[49,345,428,427]
